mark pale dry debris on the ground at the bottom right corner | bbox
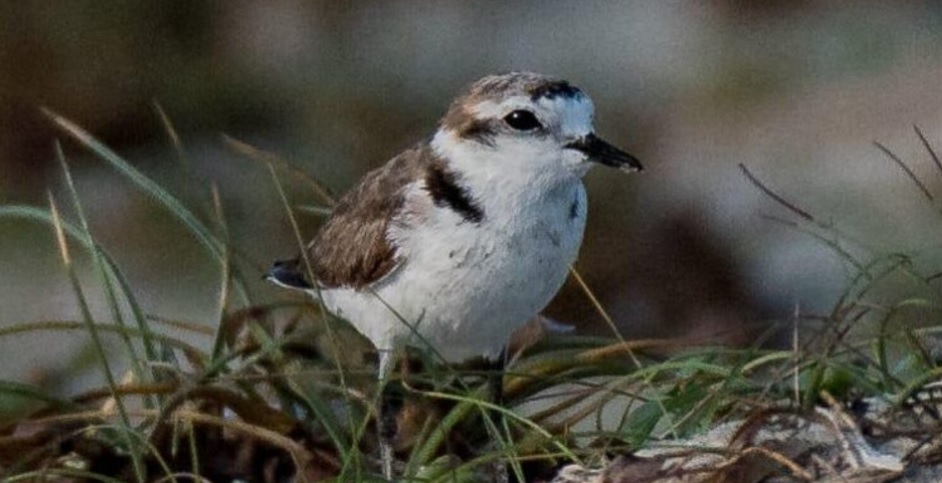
[552,395,942,483]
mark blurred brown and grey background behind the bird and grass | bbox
[0,0,942,394]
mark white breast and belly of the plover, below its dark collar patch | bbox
[322,180,586,361]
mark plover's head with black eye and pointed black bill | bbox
[433,72,642,182]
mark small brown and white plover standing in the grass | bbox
[268,72,641,476]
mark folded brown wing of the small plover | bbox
[307,143,434,289]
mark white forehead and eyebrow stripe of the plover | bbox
[471,92,595,137]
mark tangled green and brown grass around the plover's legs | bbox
[0,110,942,482]
